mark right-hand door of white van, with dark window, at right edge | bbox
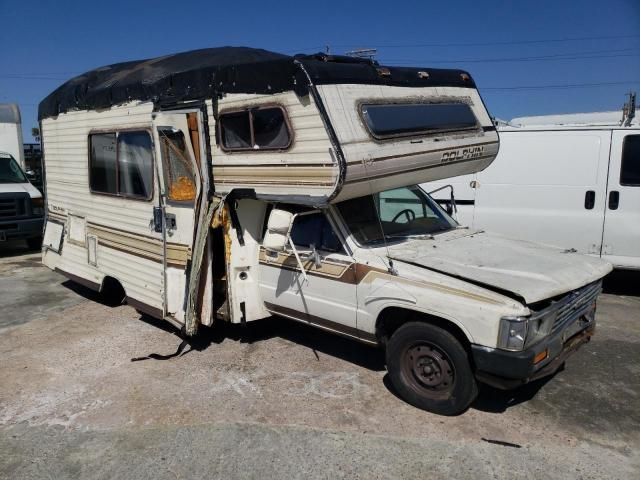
[602,130,640,268]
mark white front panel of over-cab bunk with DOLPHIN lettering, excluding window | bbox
[318,85,498,201]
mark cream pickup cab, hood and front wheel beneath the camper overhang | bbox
[260,186,611,414]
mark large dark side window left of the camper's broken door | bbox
[89,131,153,199]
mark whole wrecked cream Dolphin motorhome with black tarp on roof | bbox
[39,47,611,415]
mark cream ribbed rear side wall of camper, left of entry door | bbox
[42,103,164,309]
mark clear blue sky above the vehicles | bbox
[0,0,640,141]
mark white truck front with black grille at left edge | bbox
[0,152,44,249]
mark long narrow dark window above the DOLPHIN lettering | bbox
[360,103,478,139]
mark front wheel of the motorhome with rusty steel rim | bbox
[387,322,478,415]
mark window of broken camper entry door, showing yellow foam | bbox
[158,128,196,202]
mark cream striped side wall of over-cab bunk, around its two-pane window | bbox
[207,92,339,203]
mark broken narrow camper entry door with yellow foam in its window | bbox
[154,110,204,323]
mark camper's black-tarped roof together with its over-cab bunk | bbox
[39,47,498,205]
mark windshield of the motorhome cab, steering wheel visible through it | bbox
[337,185,457,245]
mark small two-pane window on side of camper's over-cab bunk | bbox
[219,107,291,151]
